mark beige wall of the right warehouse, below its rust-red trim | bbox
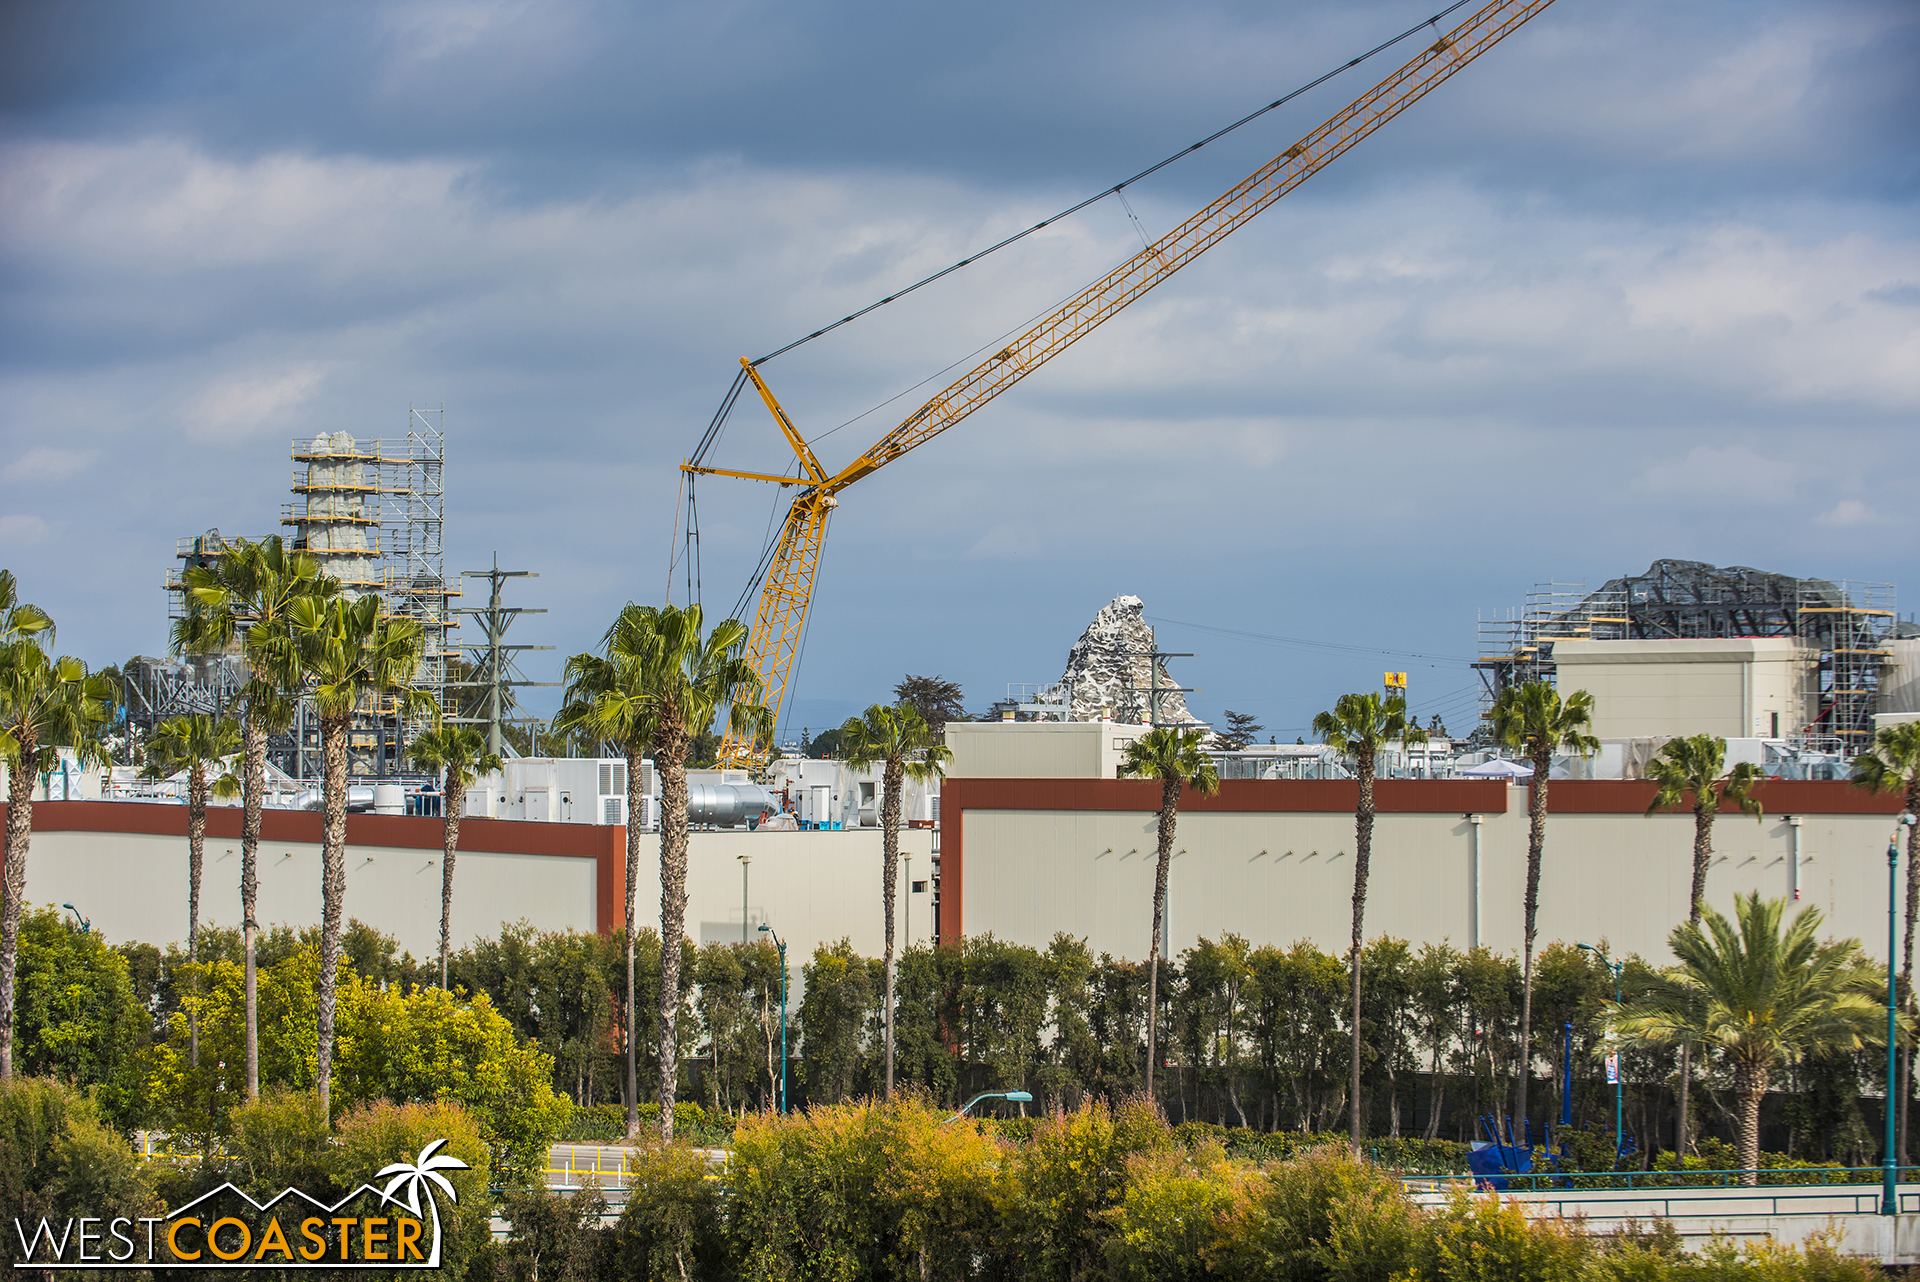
[962,789,1889,958]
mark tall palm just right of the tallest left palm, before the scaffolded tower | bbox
[286,595,432,1119]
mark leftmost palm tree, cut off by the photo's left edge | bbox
[0,587,113,1082]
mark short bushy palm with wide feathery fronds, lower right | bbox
[1607,890,1885,1184]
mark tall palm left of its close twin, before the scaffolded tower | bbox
[173,535,340,1100]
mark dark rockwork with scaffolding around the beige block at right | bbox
[1475,558,1901,754]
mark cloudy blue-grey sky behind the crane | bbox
[0,0,1920,737]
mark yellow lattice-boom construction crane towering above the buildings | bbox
[680,0,1553,766]
